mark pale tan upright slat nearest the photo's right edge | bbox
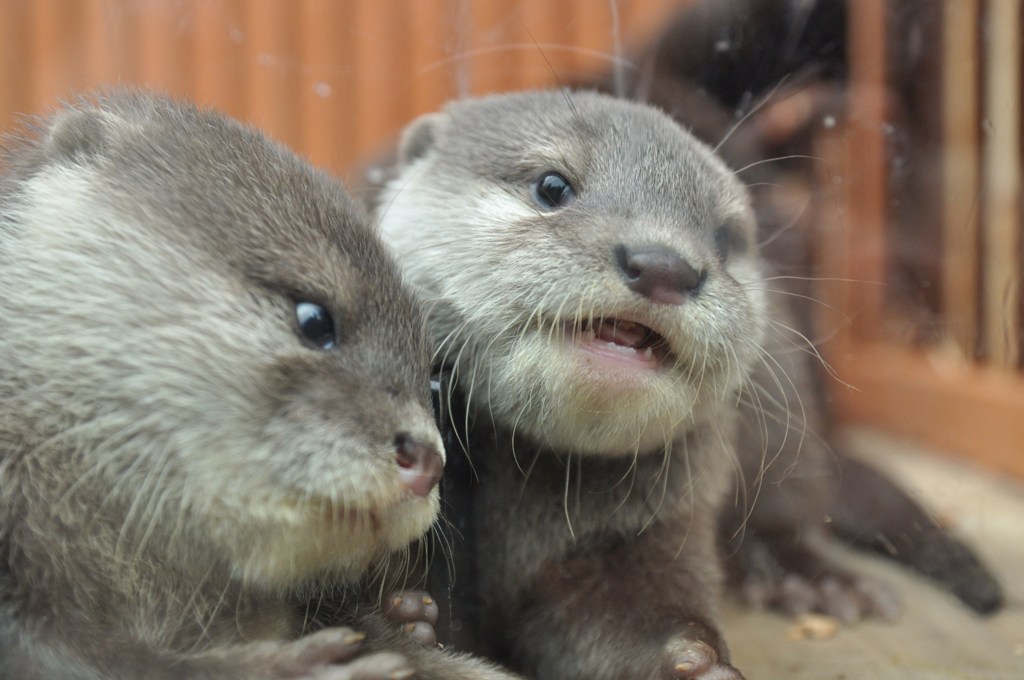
[983,0,1021,369]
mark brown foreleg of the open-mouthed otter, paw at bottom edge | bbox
[501,513,742,680]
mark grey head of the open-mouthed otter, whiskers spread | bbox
[380,87,765,455]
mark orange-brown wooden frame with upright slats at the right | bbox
[818,0,1024,478]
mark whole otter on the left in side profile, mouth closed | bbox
[0,91,512,680]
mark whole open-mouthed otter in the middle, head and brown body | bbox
[377,91,753,680]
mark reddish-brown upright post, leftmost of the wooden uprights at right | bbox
[845,0,887,335]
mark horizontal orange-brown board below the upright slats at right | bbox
[831,343,1024,479]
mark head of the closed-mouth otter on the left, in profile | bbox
[0,95,443,588]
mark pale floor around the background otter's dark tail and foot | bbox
[725,430,1024,680]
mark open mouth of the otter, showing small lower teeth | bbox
[572,318,673,370]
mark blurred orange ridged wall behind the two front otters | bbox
[0,0,681,179]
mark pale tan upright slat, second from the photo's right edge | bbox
[942,0,980,358]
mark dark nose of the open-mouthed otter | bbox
[615,244,707,304]
